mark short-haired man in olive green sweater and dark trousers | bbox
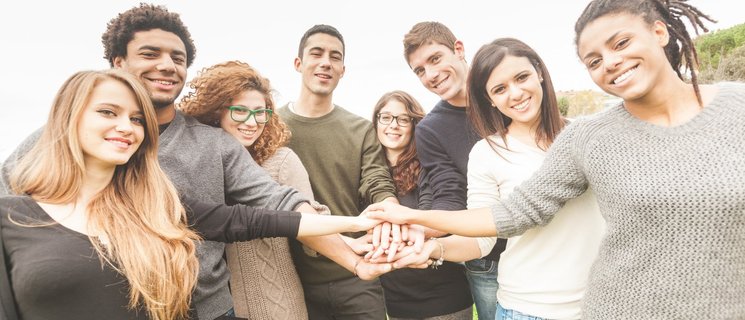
[277,25,397,320]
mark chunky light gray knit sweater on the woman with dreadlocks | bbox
[492,83,745,319]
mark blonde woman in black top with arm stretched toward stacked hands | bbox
[0,70,376,319]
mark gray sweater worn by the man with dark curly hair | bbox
[0,111,307,319]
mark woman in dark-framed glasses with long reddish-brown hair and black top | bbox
[373,91,473,320]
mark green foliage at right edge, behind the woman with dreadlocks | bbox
[694,23,745,71]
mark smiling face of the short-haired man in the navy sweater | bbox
[409,41,468,106]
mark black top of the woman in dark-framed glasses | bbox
[380,173,473,318]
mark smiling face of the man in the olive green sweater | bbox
[295,33,345,96]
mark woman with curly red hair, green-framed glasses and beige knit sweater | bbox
[179,61,313,319]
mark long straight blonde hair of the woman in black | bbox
[10,70,199,319]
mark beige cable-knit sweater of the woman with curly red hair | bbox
[225,147,313,320]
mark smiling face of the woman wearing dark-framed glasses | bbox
[375,99,414,154]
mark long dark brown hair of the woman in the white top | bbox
[466,38,565,153]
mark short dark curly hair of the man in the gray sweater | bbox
[101,3,197,67]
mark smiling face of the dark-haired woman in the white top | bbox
[486,55,543,128]
